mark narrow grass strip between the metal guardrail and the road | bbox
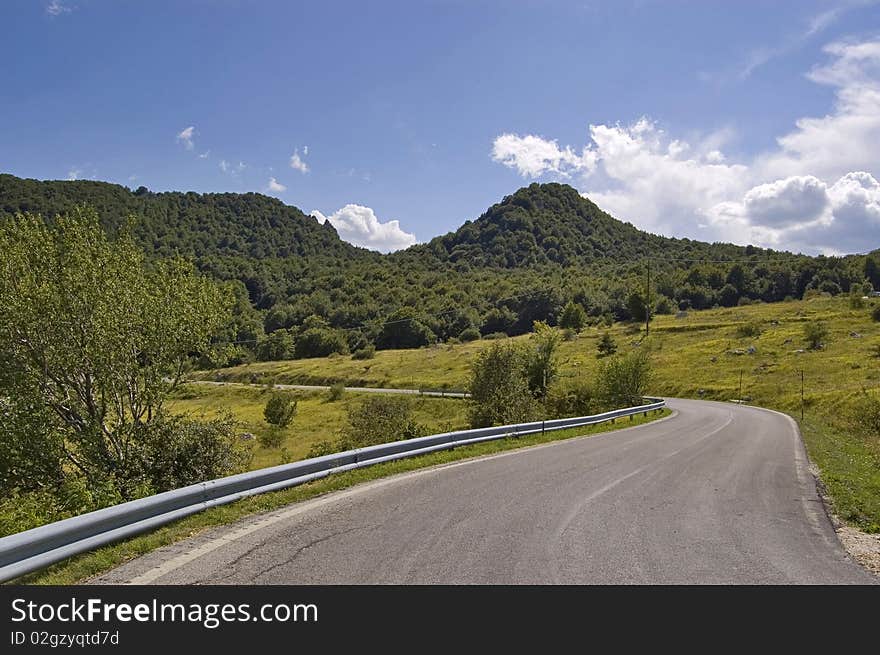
[8,410,671,585]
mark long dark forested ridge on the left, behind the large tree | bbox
[0,174,364,259]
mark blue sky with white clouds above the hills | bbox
[0,0,880,253]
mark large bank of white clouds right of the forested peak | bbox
[492,40,880,253]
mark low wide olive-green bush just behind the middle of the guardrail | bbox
[340,394,426,450]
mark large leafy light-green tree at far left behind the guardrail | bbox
[0,207,231,499]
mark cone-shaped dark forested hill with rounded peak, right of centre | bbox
[396,183,776,268]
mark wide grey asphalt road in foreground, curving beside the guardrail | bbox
[95,400,876,584]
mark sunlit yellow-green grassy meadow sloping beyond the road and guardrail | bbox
[194,297,880,532]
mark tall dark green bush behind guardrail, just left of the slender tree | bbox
[468,342,538,428]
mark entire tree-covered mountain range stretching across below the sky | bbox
[0,175,880,365]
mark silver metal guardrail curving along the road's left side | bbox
[0,398,666,582]
